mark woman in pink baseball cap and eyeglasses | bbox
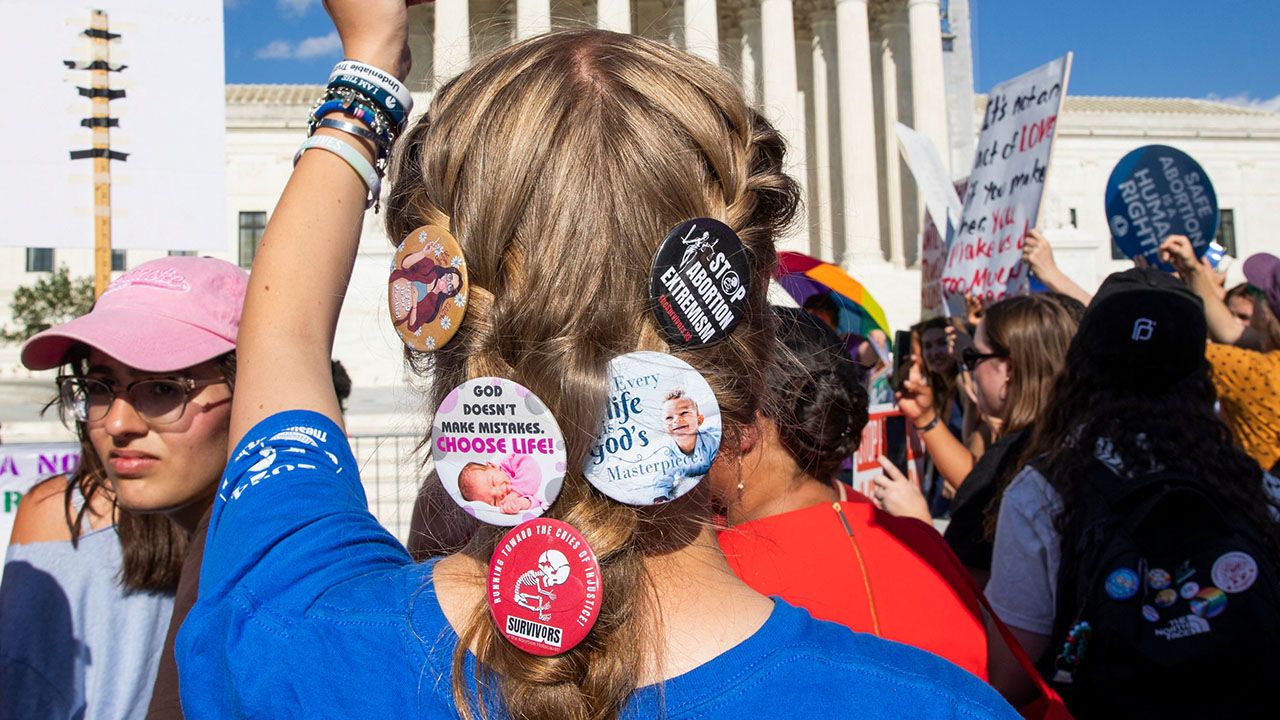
[0,258,247,719]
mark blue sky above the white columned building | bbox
[225,0,1280,111]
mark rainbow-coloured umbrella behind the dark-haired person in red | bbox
[776,252,893,338]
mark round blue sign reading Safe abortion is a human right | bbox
[1106,145,1217,270]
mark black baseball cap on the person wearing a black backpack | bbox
[1076,268,1208,393]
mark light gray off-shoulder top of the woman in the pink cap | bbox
[0,527,173,720]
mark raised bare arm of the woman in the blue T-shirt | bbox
[230,0,412,447]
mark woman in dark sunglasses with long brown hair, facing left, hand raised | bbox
[873,295,1079,584]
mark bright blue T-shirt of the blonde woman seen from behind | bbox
[177,411,1016,720]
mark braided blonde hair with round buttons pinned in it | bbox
[387,29,800,720]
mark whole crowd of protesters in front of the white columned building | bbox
[0,0,1280,719]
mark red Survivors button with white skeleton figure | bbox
[488,518,604,656]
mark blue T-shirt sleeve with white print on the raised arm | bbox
[200,410,412,615]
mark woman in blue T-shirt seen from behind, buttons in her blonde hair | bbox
[178,0,1012,720]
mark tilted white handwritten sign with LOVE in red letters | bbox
[942,53,1071,304]
